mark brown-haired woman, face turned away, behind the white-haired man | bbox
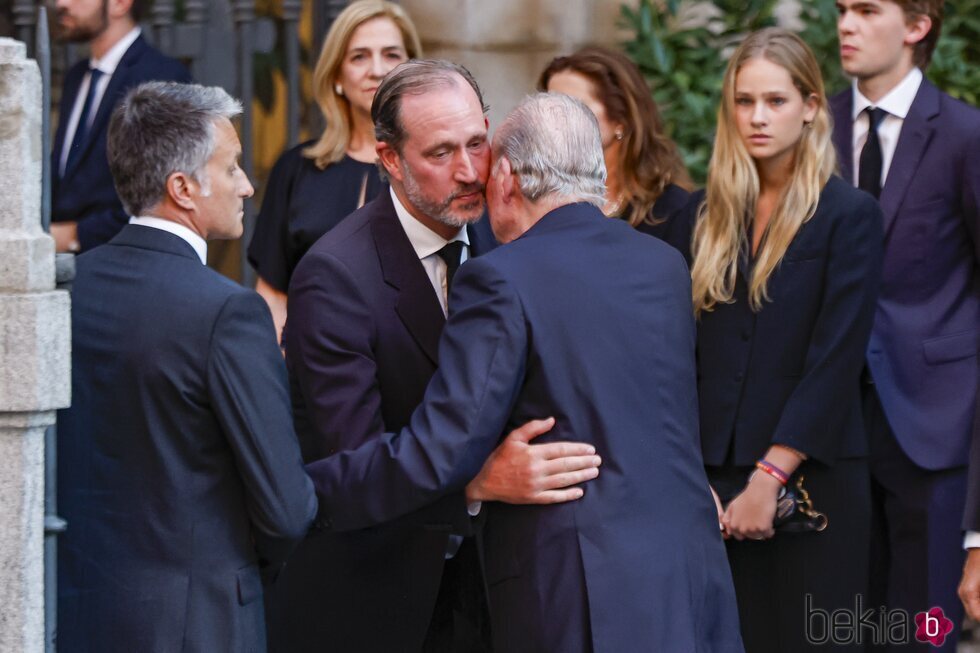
[538,47,691,239]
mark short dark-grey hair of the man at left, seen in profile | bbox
[107,82,242,215]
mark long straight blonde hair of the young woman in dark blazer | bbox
[691,27,837,315]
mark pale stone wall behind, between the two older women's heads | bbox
[401,0,637,130]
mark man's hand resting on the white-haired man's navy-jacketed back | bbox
[466,417,602,504]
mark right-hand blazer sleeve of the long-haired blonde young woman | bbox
[772,192,884,463]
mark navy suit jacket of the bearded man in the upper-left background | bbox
[51,36,191,251]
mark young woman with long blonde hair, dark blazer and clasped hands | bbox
[676,28,883,653]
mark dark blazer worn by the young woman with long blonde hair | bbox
[678,176,883,465]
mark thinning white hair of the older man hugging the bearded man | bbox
[493,93,606,208]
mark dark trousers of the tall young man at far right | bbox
[864,384,966,653]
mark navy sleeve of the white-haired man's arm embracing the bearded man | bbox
[307,259,528,530]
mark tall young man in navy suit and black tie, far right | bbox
[831,0,980,650]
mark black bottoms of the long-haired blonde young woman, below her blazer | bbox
[707,458,871,653]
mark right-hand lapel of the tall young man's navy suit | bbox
[880,79,939,238]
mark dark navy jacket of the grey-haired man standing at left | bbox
[58,225,316,653]
